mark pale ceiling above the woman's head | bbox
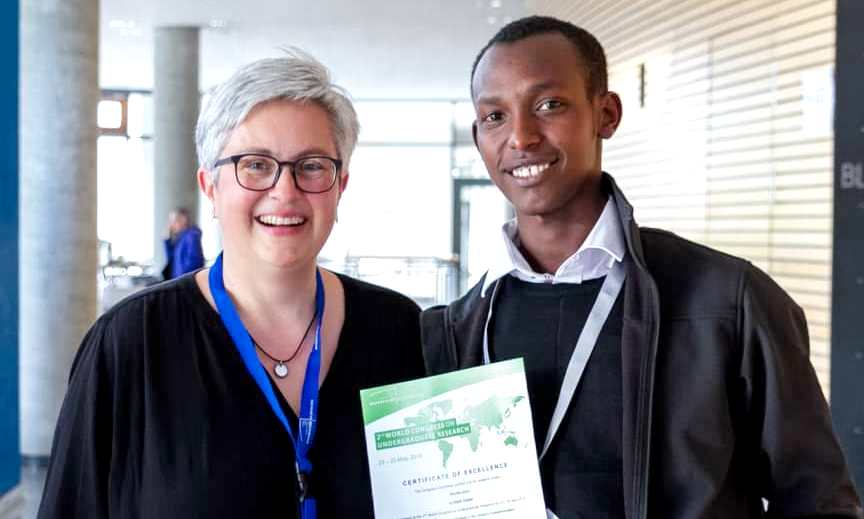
[99,0,527,99]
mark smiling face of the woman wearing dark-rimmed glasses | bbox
[199,99,348,272]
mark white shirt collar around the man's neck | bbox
[480,197,627,297]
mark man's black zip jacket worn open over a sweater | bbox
[421,174,864,519]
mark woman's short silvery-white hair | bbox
[195,47,360,181]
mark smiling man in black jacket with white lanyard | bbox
[422,17,862,519]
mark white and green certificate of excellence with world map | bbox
[360,359,546,519]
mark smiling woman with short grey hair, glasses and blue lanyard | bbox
[40,50,423,519]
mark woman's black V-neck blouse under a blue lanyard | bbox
[39,275,424,519]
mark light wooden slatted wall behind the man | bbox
[529,0,836,400]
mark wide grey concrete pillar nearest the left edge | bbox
[19,0,99,457]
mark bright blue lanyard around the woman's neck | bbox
[209,254,324,519]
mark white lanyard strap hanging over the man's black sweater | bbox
[483,261,626,460]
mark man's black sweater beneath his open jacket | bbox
[489,276,624,519]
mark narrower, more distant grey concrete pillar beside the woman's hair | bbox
[153,27,200,268]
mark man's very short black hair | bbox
[471,16,608,96]
